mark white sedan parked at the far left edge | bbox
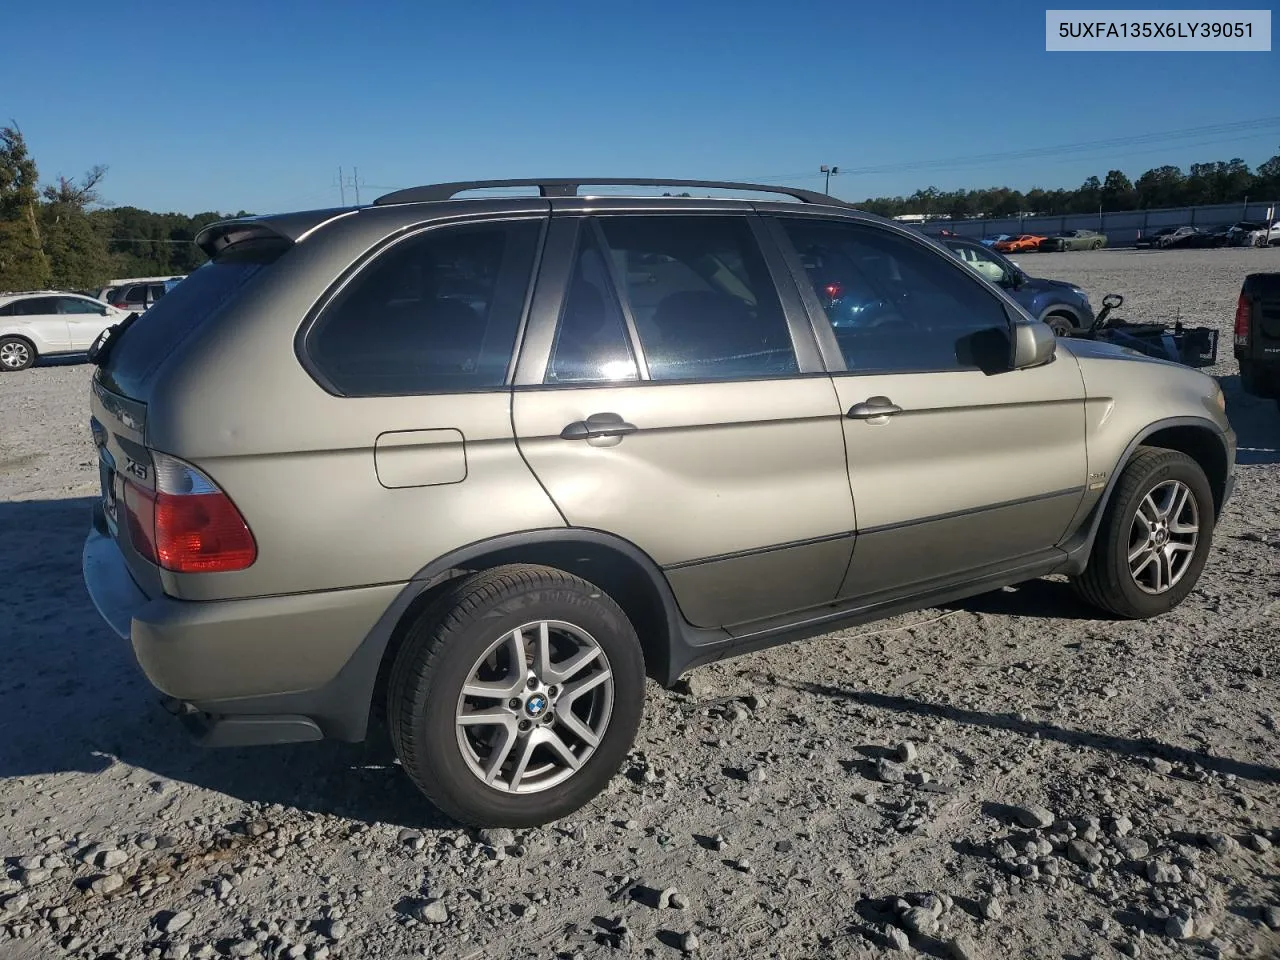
[0,291,128,371]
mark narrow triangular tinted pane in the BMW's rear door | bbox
[547,223,640,383]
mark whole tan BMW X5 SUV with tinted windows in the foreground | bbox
[83,179,1235,826]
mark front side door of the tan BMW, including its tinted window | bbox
[774,216,1088,598]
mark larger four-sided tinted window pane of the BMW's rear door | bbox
[599,216,799,380]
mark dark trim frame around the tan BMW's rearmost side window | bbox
[293,210,550,399]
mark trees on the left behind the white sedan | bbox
[0,125,244,291]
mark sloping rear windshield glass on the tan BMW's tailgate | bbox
[102,241,289,398]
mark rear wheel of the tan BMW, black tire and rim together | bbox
[388,564,645,827]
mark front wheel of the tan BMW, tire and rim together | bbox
[1071,447,1215,620]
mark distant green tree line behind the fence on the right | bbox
[858,154,1280,220]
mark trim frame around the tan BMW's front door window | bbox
[764,212,1023,376]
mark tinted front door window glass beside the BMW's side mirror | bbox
[782,218,1009,372]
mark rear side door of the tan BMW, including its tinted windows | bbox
[513,211,854,627]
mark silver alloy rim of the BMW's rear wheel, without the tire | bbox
[454,620,613,794]
